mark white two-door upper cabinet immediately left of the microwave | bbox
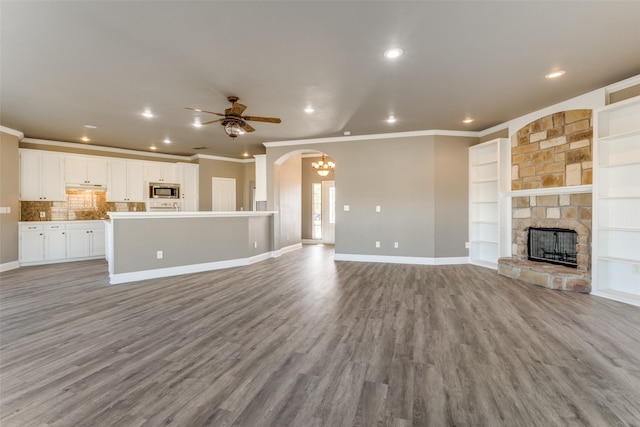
[107,159,146,202]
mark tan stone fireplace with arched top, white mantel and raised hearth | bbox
[498,110,593,292]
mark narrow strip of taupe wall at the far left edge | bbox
[0,132,20,264]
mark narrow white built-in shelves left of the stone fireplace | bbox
[469,138,506,269]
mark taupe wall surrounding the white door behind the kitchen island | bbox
[198,158,255,211]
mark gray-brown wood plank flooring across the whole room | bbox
[0,246,640,427]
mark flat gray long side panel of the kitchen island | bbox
[113,217,255,274]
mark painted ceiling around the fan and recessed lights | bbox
[0,1,640,157]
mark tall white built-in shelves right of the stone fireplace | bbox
[592,97,640,305]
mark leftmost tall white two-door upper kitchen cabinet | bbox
[20,149,65,202]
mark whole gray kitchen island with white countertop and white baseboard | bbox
[105,211,278,284]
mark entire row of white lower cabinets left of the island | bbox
[19,221,105,265]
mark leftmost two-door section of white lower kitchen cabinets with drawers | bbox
[19,222,66,264]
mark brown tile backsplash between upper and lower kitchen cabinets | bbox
[20,190,146,221]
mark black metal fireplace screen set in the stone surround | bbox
[527,228,578,268]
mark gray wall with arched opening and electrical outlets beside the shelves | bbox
[267,136,477,258]
